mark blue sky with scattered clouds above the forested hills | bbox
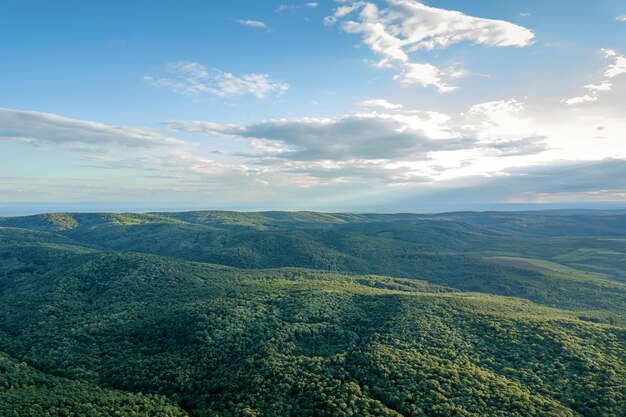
[0,0,626,214]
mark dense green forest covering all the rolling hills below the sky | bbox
[0,212,626,417]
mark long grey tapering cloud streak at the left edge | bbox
[0,109,185,148]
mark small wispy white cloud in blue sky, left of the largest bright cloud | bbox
[143,61,289,98]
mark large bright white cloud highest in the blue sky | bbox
[324,0,534,92]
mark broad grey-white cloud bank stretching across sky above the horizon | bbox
[0,95,626,208]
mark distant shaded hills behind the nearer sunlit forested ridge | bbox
[0,212,626,316]
